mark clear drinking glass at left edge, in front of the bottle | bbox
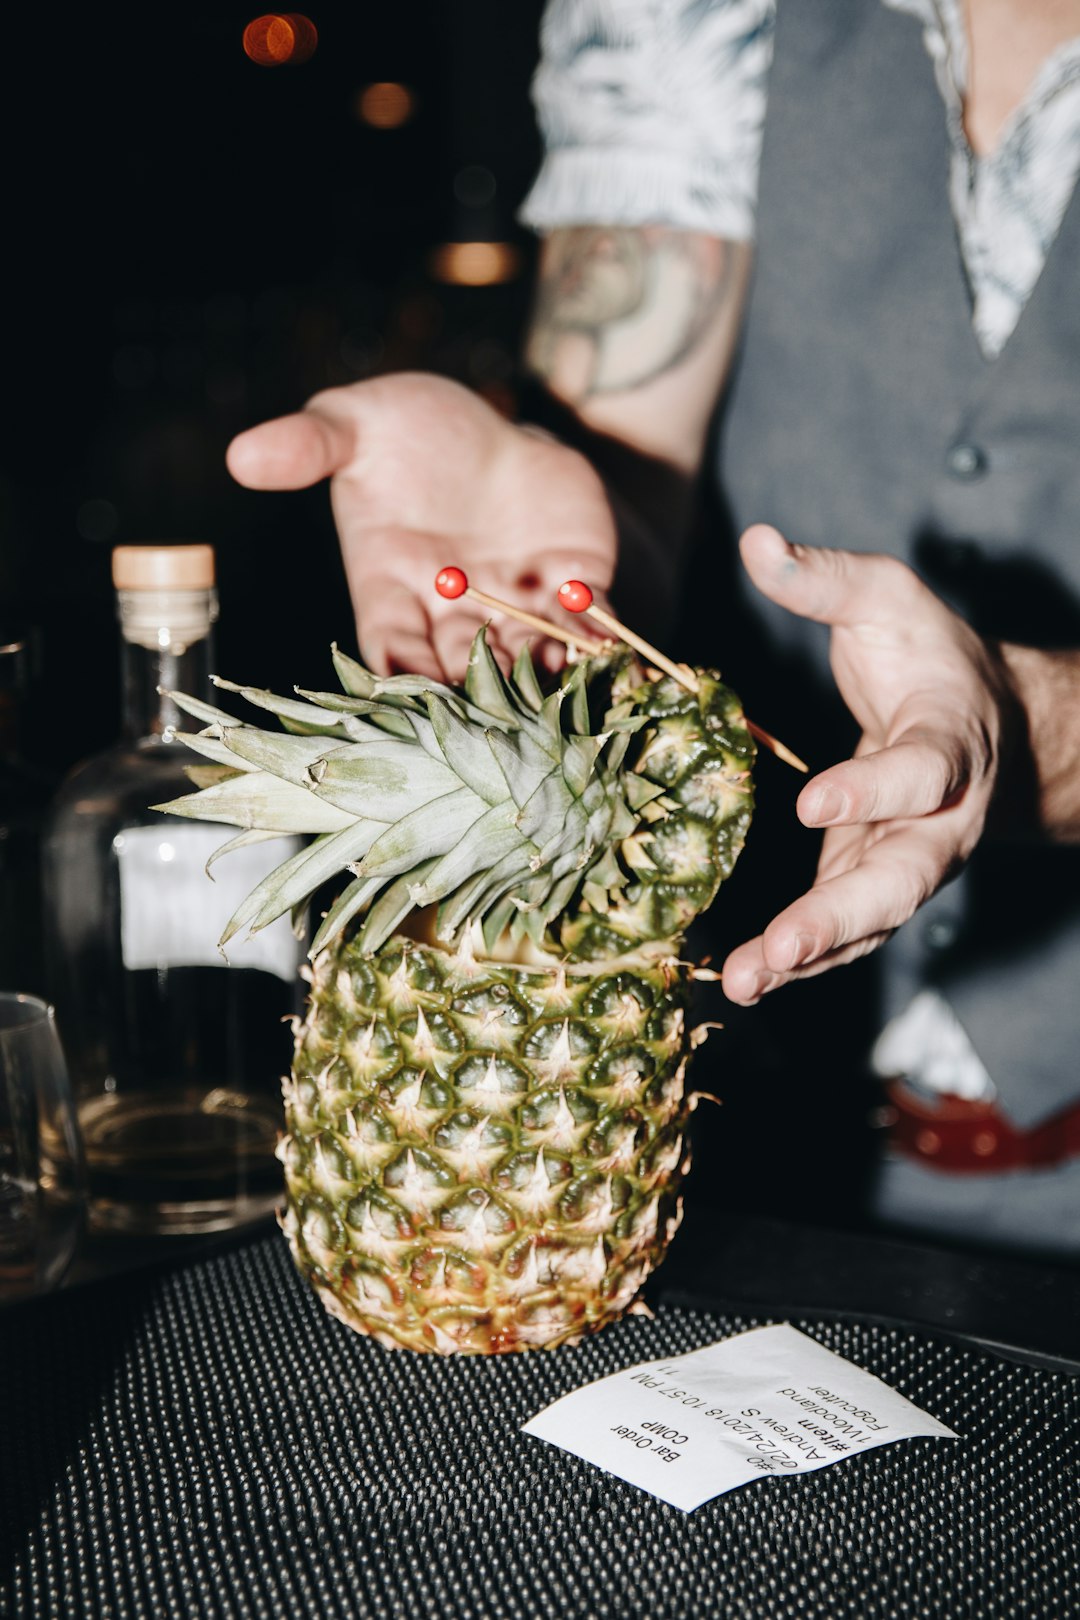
[0,991,86,1302]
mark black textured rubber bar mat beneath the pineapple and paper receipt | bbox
[0,1234,1080,1620]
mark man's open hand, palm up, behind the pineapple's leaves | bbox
[227,373,615,680]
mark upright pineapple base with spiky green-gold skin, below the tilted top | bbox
[280,936,690,1354]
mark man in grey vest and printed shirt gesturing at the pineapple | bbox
[230,0,1080,1254]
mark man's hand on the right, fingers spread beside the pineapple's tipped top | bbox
[724,525,1023,1004]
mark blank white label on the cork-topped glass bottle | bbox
[113,823,304,983]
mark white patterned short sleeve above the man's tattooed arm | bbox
[520,0,776,240]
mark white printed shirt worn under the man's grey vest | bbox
[521,0,1080,358]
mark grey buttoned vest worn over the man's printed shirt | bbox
[719,0,1080,1249]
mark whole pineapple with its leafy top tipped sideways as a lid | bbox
[159,630,755,1353]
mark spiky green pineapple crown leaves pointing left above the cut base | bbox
[155,630,753,956]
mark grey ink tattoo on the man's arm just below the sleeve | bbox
[526,225,738,405]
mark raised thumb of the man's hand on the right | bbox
[738,523,947,627]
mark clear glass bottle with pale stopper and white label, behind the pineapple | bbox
[44,546,304,1233]
